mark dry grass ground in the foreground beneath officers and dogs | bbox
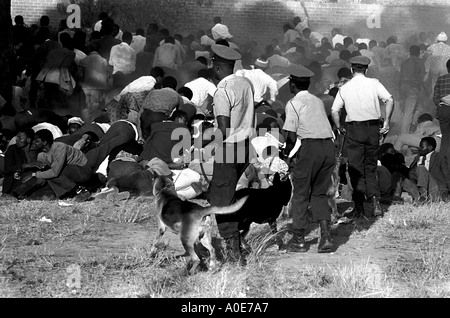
[0,197,450,298]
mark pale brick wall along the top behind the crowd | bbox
[8,0,450,45]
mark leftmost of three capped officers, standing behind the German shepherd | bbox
[203,44,255,265]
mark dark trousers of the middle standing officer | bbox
[291,138,336,230]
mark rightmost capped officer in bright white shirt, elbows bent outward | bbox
[331,56,394,217]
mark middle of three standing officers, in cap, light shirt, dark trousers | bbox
[283,65,335,253]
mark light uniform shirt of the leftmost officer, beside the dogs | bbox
[213,74,255,143]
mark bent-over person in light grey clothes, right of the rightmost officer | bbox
[394,113,441,153]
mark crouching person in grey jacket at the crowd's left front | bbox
[16,129,92,201]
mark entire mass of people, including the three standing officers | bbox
[0,9,450,261]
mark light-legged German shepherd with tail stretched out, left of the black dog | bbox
[153,175,247,274]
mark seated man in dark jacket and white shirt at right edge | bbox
[409,137,450,201]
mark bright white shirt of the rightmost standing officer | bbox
[331,74,392,122]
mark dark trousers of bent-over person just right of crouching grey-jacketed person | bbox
[86,121,136,172]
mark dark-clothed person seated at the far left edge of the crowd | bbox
[2,128,37,194]
